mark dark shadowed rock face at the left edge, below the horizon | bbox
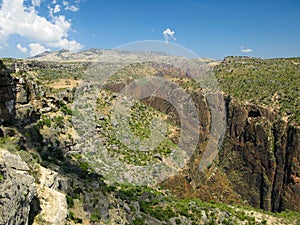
[0,60,16,124]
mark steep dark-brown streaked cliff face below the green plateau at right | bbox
[219,97,300,211]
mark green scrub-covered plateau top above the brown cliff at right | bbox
[214,57,300,125]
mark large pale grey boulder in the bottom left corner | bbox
[0,149,36,225]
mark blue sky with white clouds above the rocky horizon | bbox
[0,0,300,59]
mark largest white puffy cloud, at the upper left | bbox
[0,0,83,52]
